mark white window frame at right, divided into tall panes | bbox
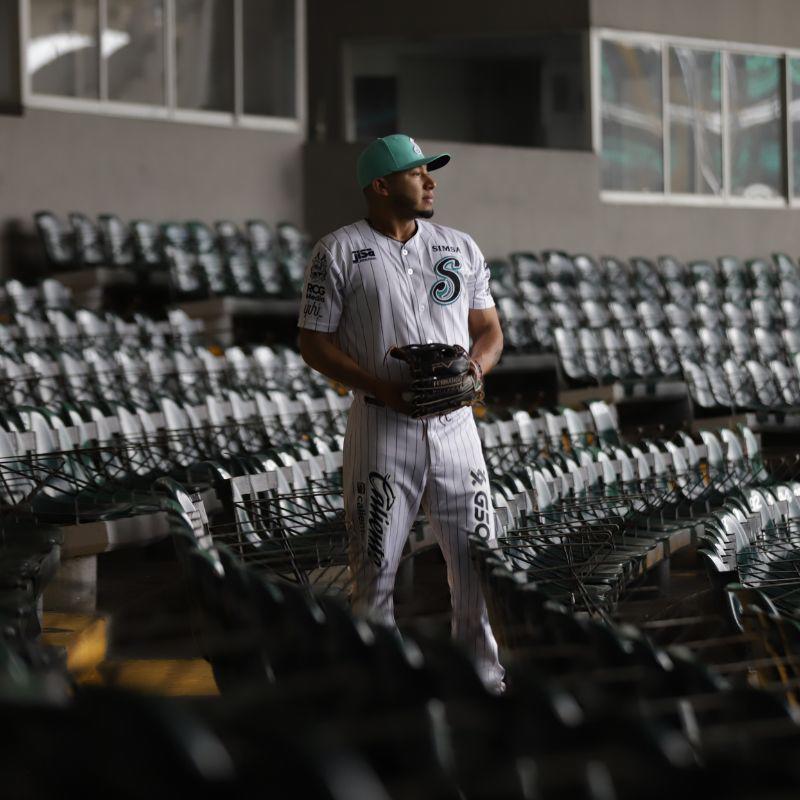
[589,28,800,208]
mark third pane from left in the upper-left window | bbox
[175,0,233,112]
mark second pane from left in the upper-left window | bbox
[103,0,164,105]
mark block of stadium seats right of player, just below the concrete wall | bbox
[492,251,800,409]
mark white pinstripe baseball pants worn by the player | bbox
[344,395,505,688]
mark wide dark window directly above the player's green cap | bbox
[345,33,591,150]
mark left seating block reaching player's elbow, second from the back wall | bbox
[0,280,338,410]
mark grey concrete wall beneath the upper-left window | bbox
[0,109,303,276]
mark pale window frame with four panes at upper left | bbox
[19,0,307,136]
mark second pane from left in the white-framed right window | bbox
[669,47,722,195]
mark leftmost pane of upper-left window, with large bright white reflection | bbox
[27,0,99,99]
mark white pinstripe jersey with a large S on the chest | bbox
[298,219,494,380]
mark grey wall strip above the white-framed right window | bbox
[591,0,800,47]
